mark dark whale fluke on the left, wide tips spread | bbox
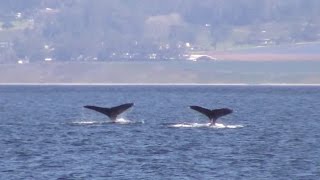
[83,103,134,121]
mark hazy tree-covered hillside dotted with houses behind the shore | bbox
[0,0,320,63]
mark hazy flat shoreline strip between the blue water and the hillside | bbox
[0,60,320,83]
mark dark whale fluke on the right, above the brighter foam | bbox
[190,106,232,125]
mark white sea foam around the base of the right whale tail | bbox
[169,123,244,129]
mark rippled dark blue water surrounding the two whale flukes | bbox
[0,86,320,179]
